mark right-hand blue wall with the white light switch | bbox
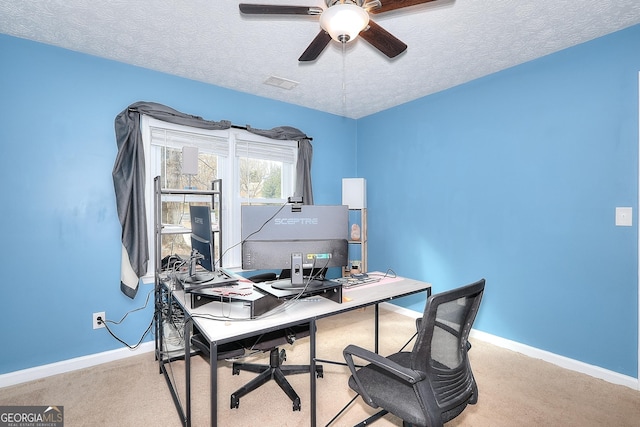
[357,26,640,378]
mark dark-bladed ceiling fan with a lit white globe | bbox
[240,0,434,61]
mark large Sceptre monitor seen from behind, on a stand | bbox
[241,204,349,289]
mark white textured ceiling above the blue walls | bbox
[0,0,640,118]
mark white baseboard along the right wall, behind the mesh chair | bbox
[380,303,640,390]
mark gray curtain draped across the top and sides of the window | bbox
[112,102,313,298]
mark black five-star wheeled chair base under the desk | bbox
[231,348,323,411]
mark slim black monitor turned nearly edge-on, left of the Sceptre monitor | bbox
[185,205,215,283]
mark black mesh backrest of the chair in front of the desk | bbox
[411,279,485,422]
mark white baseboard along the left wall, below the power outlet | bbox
[0,341,155,388]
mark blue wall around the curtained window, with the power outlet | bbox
[0,35,356,374]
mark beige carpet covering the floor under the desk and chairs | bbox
[0,308,640,427]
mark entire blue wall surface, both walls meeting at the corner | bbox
[0,26,640,377]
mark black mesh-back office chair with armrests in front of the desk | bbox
[343,279,485,427]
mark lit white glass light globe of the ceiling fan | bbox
[320,3,369,43]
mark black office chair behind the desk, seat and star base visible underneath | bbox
[231,273,323,411]
